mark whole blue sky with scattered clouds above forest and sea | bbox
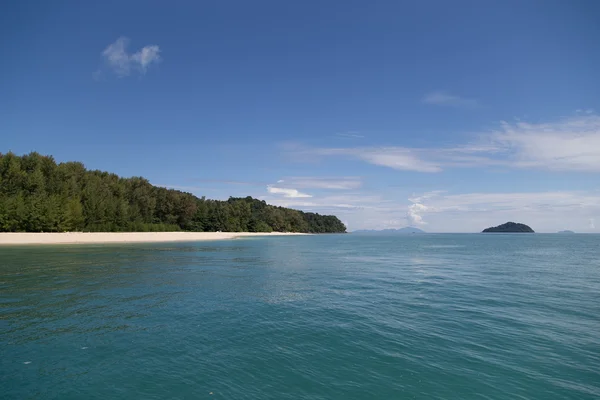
[0,0,600,232]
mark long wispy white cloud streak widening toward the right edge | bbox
[288,113,600,172]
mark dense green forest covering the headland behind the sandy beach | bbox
[0,152,346,233]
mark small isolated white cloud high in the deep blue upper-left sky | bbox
[102,37,161,77]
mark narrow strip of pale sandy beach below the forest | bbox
[0,232,308,246]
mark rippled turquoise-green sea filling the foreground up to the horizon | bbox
[0,234,600,400]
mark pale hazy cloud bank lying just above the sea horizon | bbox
[262,186,600,232]
